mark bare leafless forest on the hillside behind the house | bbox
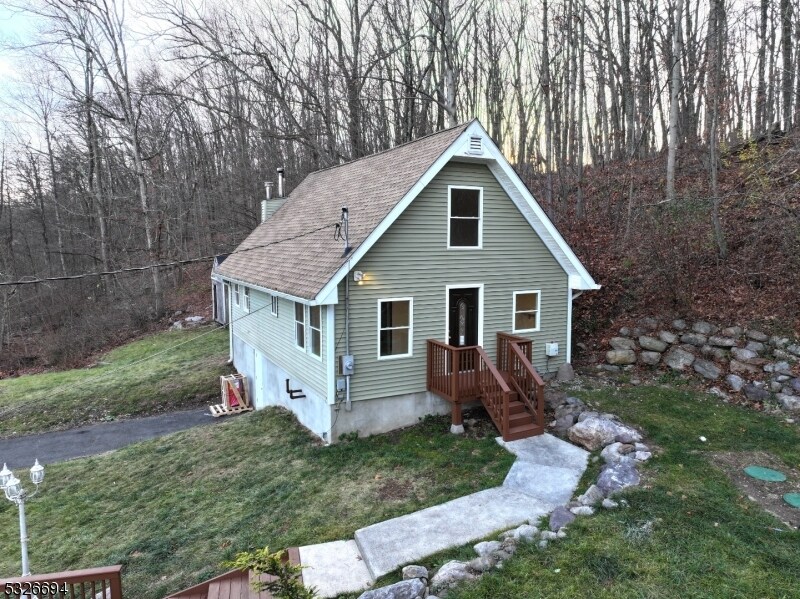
[0,0,800,370]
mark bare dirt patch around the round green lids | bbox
[711,451,800,528]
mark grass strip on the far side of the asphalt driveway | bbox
[0,328,230,437]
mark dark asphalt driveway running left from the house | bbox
[0,408,219,469]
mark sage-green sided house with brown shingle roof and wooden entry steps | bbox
[216,120,599,441]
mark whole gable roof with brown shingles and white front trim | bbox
[217,120,599,303]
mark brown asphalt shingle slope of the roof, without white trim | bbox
[217,123,469,299]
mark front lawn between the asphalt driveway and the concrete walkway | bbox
[0,409,513,599]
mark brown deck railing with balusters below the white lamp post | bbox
[0,566,122,599]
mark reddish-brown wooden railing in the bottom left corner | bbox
[0,566,122,599]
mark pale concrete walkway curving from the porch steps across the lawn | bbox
[300,434,589,597]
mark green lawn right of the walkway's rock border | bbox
[438,387,800,599]
